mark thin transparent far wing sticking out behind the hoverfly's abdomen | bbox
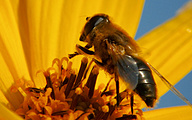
[147,63,192,107]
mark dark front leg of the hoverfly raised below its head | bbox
[69,44,95,59]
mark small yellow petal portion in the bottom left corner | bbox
[0,104,23,120]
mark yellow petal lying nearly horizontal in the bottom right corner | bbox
[143,106,192,120]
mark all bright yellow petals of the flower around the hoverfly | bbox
[0,0,192,119]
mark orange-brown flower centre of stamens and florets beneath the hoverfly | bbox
[11,57,142,120]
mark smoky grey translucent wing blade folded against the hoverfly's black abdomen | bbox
[116,54,139,90]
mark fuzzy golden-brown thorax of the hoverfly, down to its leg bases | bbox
[86,22,139,74]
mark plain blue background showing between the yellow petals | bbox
[135,0,192,109]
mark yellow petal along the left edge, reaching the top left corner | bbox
[0,1,29,79]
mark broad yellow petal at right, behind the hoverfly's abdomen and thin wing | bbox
[138,1,192,96]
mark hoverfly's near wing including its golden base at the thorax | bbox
[106,41,139,90]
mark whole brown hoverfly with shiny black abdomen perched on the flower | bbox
[69,14,192,107]
